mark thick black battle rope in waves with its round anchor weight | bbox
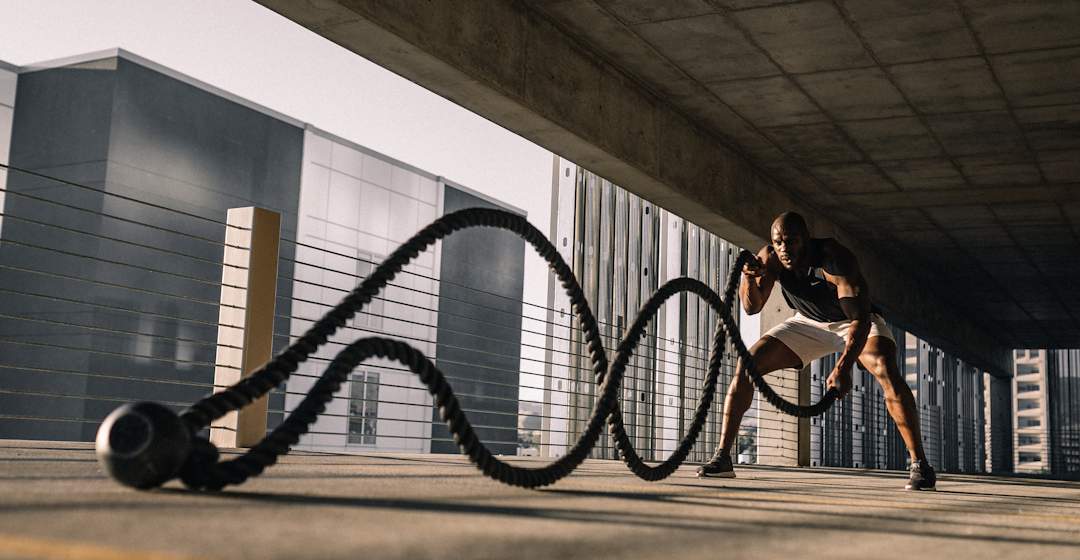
[97,208,837,490]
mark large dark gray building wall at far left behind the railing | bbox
[0,57,303,440]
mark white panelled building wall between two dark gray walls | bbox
[284,126,444,453]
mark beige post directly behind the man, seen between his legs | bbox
[757,284,810,466]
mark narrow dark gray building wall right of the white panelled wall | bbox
[431,185,525,455]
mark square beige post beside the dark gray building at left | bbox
[210,206,281,448]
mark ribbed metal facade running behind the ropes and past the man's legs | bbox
[557,160,986,473]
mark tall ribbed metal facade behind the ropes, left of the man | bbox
[540,158,743,461]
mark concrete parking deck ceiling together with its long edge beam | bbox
[259,0,1080,367]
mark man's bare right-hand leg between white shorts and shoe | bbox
[859,337,927,463]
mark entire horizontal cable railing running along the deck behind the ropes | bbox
[0,162,977,476]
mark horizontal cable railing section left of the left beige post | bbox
[0,168,243,440]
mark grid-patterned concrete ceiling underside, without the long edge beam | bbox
[524,0,1080,347]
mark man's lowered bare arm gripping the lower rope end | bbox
[823,243,870,398]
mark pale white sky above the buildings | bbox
[0,0,565,399]
